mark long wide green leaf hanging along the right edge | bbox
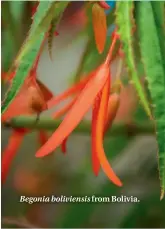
[137,2,165,199]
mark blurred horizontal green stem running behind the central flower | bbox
[4,116,154,136]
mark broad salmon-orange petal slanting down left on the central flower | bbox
[36,64,110,157]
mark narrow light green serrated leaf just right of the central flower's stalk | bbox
[116,1,152,118]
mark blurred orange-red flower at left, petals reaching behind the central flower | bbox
[2,63,89,182]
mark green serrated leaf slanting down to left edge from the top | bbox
[1,2,67,113]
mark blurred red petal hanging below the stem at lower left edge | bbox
[1,130,26,183]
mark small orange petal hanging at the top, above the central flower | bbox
[92,3,107,53]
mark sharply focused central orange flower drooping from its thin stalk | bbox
[36,31,122,186]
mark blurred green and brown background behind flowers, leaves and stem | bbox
[1,1,165,228]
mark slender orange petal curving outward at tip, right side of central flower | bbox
[96,78,122,186]
